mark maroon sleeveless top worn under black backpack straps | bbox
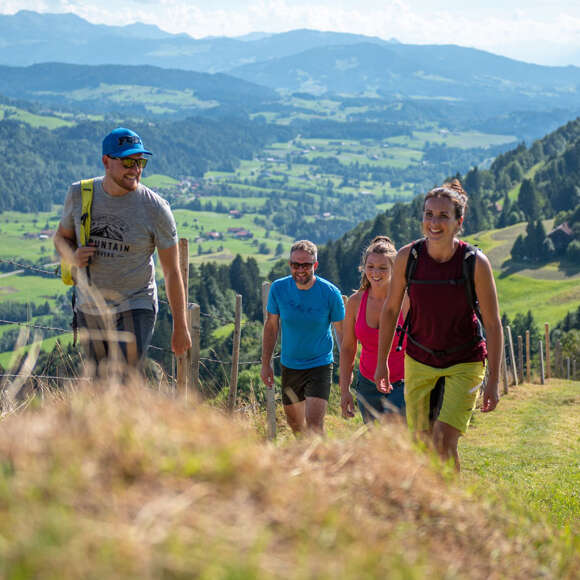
[407,241,487,368]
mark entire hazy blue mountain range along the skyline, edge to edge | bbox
[0,11,580,109]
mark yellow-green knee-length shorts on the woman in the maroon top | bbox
[405,355,485,433]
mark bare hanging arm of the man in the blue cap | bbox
[157,244,191,356]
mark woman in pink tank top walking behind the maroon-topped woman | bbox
[339,236,408,423]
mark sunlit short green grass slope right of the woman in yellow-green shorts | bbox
[460,379,580,532]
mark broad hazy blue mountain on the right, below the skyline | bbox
[230,42,580,110]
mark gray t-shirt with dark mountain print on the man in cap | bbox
[60,177,177,314]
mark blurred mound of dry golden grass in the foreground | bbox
[0,380,580,580]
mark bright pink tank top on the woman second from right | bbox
[354,289,407,383]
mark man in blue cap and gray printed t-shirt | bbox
[54,127,191,366]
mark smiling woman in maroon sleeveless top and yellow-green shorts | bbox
[374,179,503,471]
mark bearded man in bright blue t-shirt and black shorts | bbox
[261,240,344,434]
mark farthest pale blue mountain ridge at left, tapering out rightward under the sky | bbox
[0,10,389,73]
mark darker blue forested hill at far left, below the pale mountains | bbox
[0,63,276,114]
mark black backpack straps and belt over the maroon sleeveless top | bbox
[397,239,485,357]
